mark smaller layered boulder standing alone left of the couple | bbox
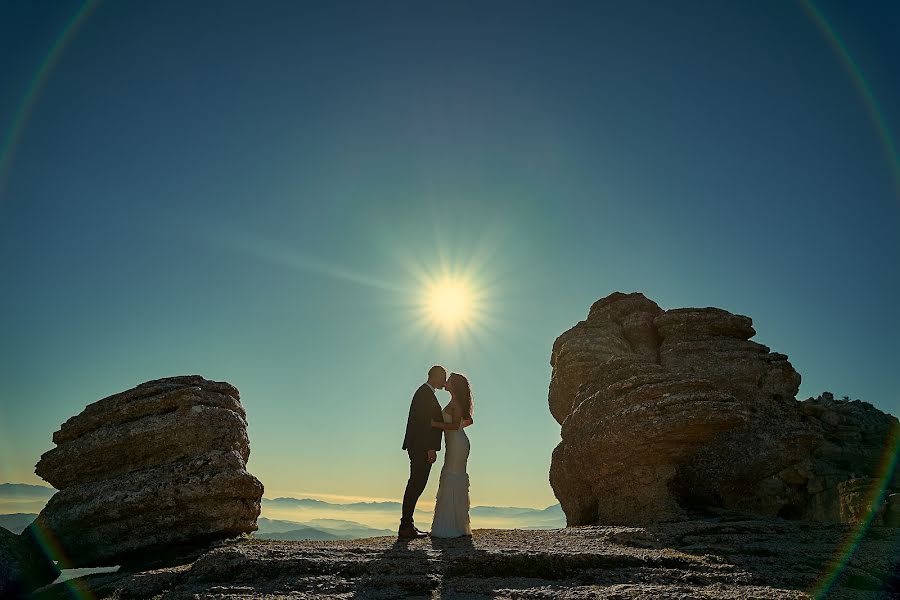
[23,375,263,567]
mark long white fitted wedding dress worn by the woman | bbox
[431,411,472,538]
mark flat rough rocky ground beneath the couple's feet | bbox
[29,513,900,599]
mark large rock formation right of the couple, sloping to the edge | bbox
[549,292,900,525]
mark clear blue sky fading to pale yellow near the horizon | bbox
[0,2,900,506]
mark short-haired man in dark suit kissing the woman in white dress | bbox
[397,365,447,538]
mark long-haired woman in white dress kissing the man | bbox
[431,373,474,538]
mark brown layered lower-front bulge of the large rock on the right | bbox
[551,357,746,524]
